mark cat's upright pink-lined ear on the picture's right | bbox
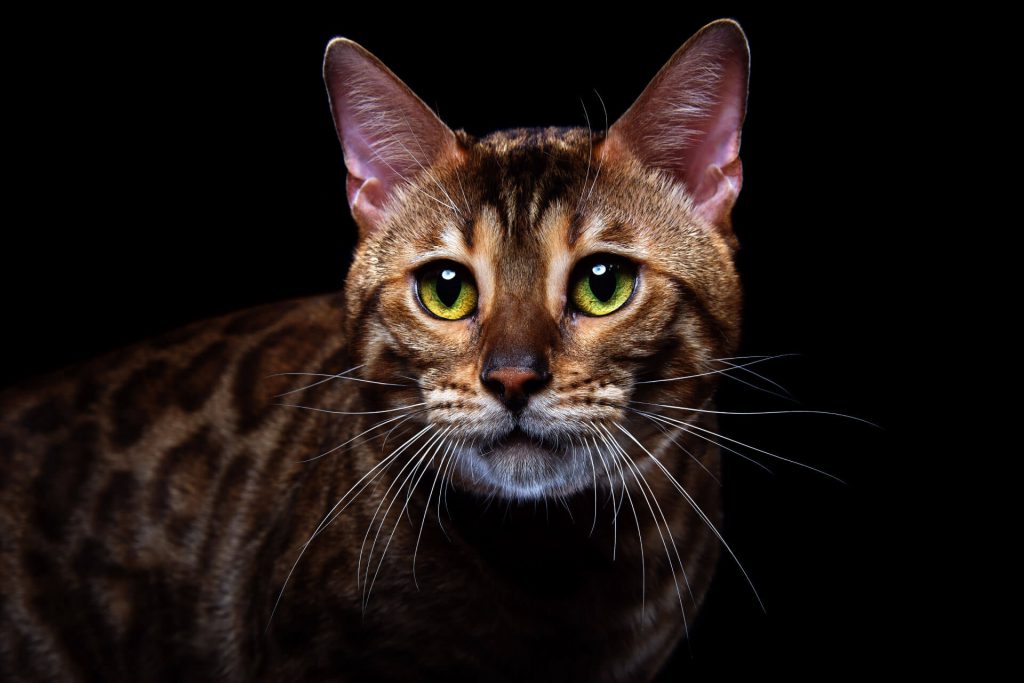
[603,19,751,242]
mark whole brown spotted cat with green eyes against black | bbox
[0,19,750,681]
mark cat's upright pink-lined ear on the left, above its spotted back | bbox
[324,38,457,238]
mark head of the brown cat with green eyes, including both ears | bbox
[324,20,750,499]
